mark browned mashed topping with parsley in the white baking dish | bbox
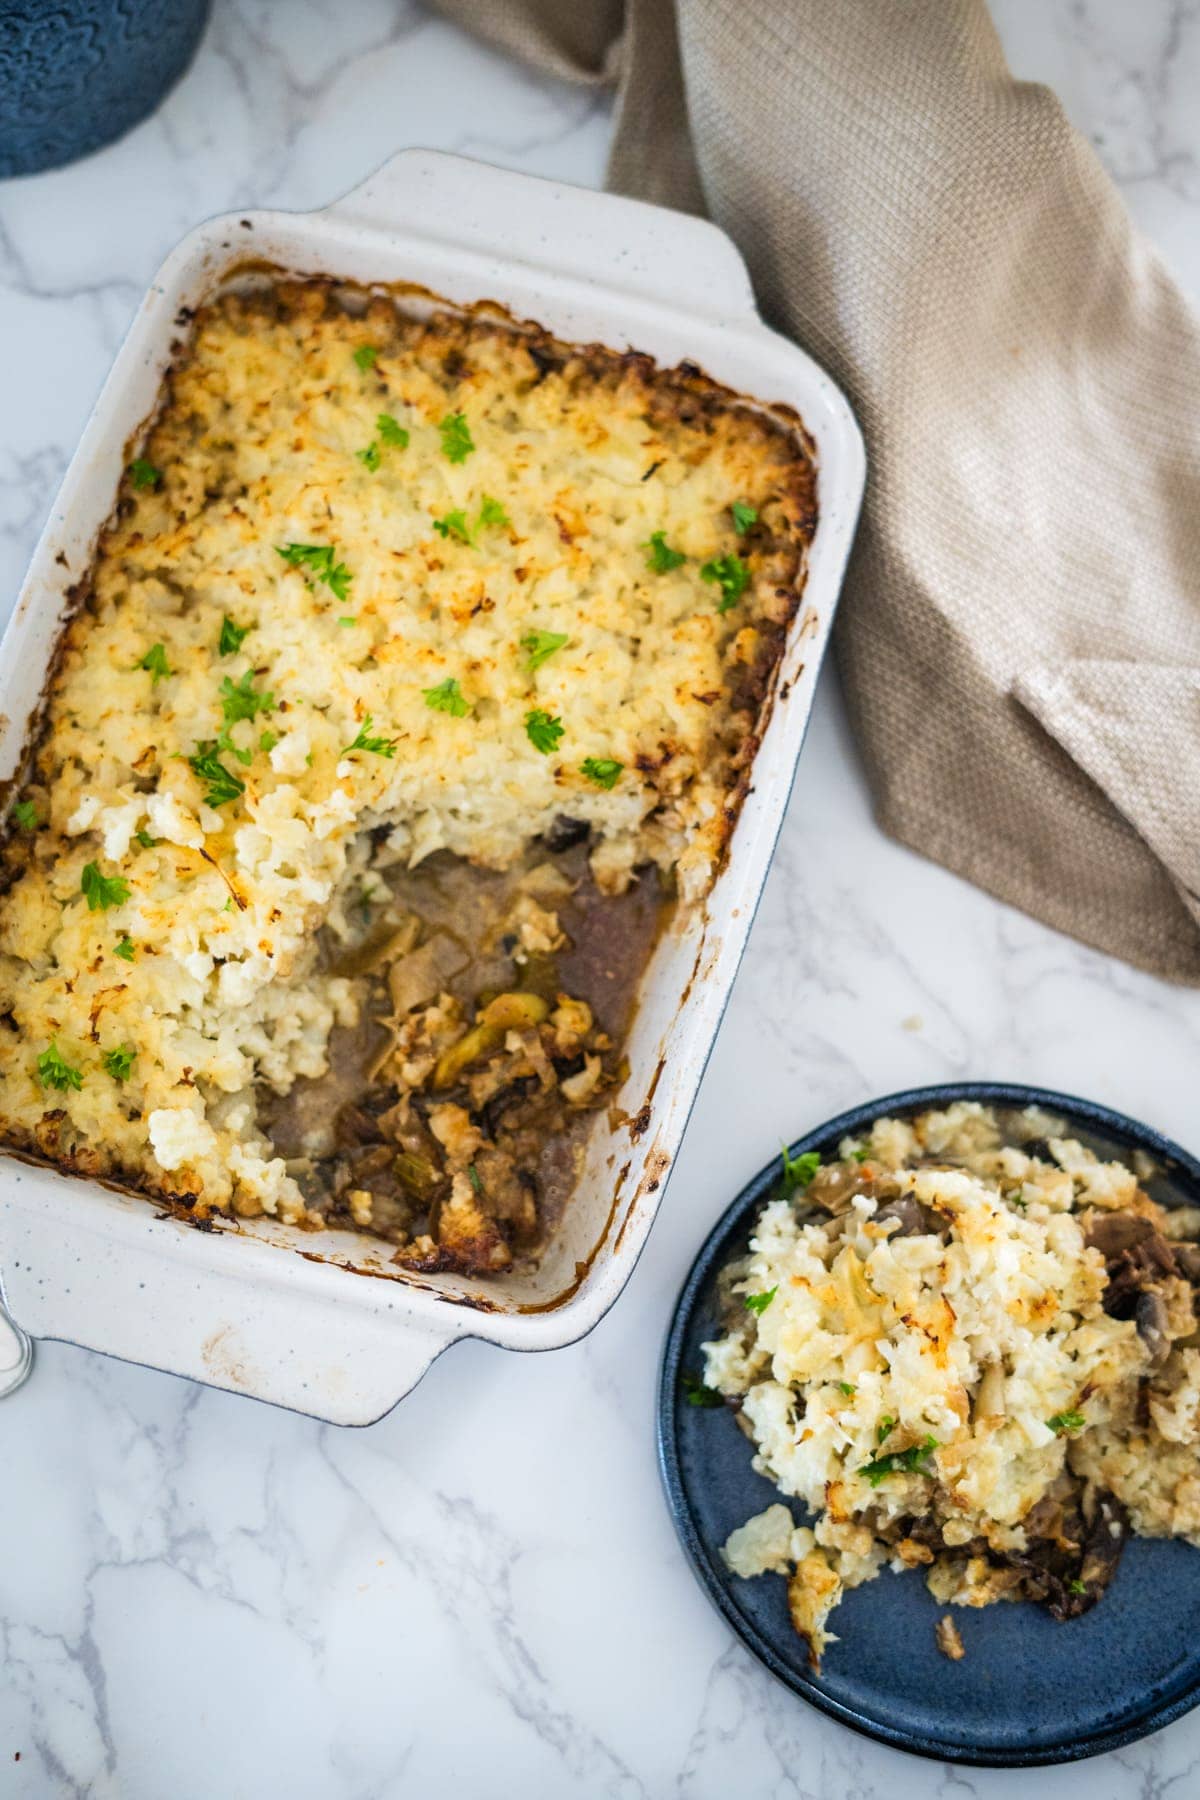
[0,283,813,1224]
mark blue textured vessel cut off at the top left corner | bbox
[0,0,209,176]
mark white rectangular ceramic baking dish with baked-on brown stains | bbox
[0,149,864,1424]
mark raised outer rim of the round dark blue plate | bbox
[655,1082,1200,1769]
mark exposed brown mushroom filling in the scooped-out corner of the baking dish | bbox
[259,819,669,1273]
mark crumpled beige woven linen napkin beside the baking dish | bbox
[437,0,1200,981]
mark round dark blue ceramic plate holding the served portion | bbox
[658,1084,1200,1766]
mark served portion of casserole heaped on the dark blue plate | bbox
[693,1102,1200,1669]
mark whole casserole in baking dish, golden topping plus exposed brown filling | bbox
[0,274,815,1273]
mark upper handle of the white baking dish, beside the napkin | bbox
[322,149,757,320]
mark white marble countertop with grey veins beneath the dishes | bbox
[0,0,1200,1800]
